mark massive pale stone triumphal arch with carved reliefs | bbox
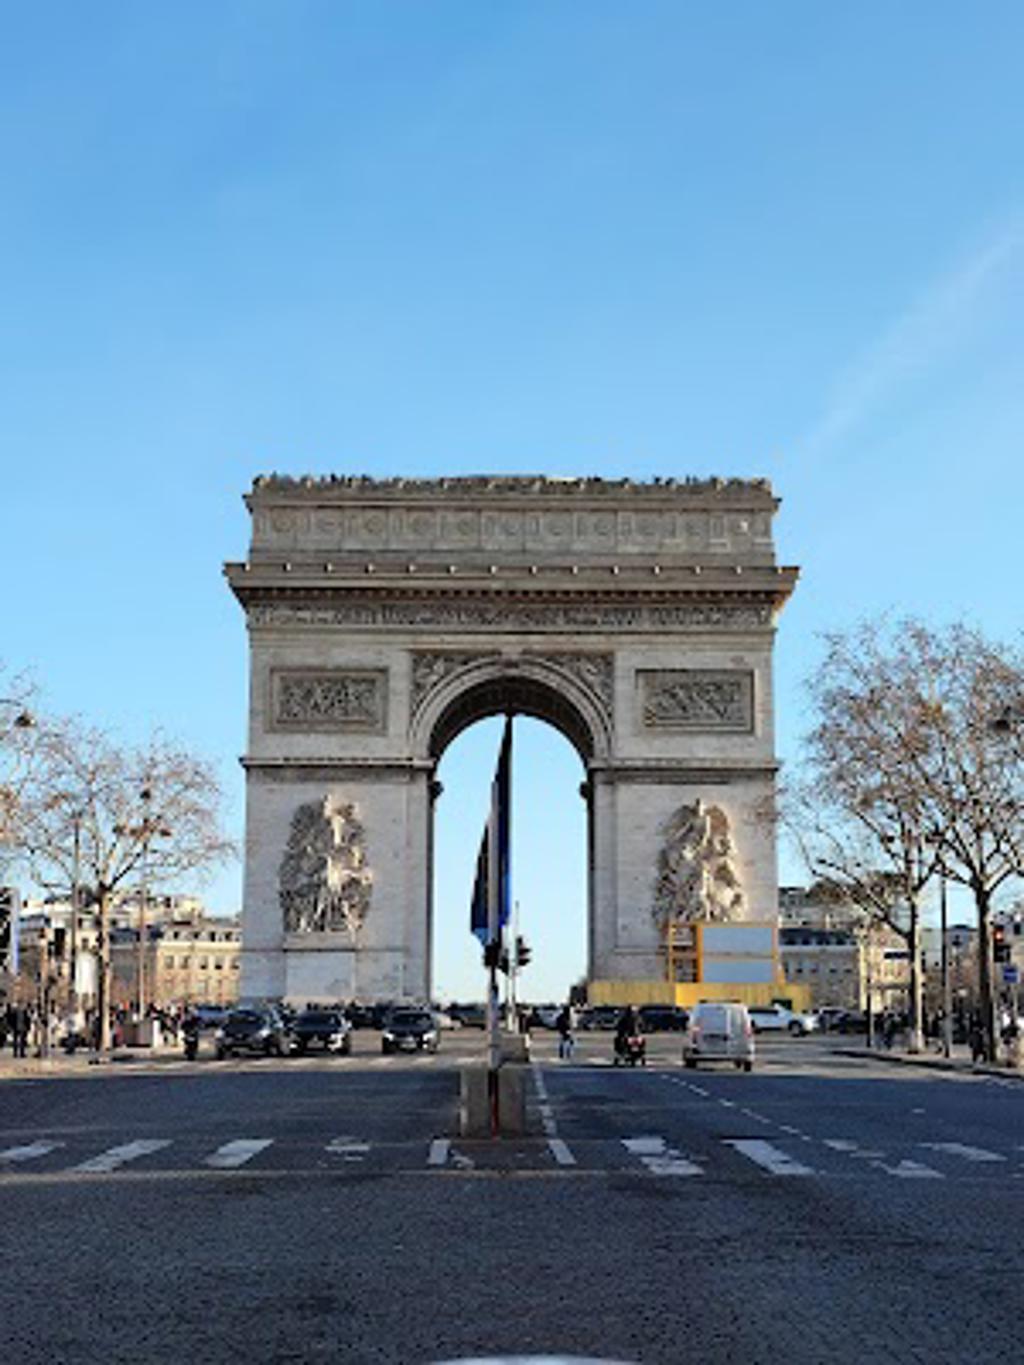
[225,476,796,1001]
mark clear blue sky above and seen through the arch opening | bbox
[0,0,1024,996]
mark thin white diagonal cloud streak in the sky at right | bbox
[801,218,1024,455]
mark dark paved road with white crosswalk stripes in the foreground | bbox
[0,1035,1024,1365]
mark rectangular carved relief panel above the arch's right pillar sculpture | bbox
[636,669,754,734]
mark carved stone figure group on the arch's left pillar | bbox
[279,796,373,936]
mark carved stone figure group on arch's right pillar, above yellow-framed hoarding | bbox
[654,800,743,928]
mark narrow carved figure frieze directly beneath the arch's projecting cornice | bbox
[248,599,774,632]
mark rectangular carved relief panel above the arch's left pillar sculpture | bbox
[268,669,388,734]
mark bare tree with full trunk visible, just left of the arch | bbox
[18,719,235,1050]
